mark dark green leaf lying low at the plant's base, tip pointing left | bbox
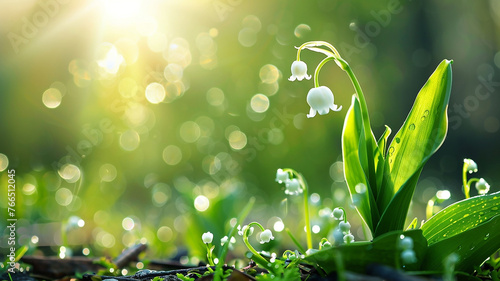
[305,229,427,274]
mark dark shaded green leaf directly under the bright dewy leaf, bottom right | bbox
[421,215,500,273]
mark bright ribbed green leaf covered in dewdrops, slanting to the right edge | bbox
[422,189,500,245]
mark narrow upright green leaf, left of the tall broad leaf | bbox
[342,95,379,232]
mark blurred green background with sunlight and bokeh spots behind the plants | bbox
[0,0,500,262]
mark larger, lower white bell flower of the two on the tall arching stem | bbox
[307,86,342,118]
